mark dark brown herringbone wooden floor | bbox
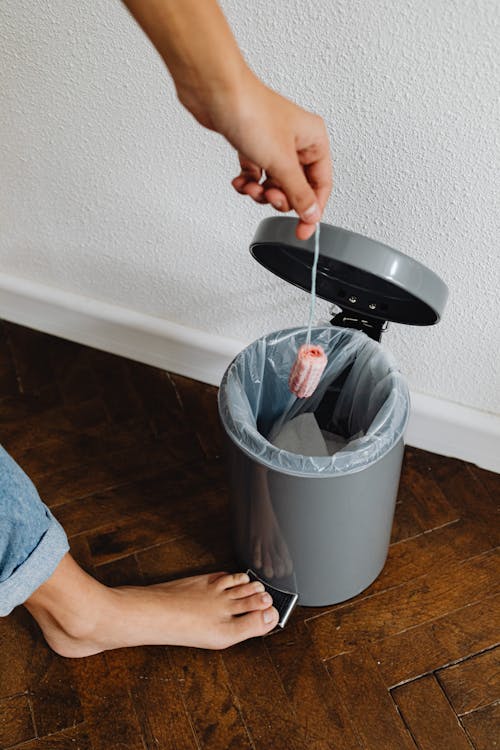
[0,324,500,750]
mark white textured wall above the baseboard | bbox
[0,0,500,412]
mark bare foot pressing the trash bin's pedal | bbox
[25,555,278,657]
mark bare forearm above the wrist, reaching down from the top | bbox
[119,0,250,126]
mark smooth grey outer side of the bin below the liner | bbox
[228,428,404,607]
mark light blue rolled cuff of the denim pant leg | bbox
[0,507,69,617]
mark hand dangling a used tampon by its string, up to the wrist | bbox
[185,71,332,240]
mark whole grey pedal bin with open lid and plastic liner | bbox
[219,217,447,606]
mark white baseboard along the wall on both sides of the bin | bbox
[0,274,500,472]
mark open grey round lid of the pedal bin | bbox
[250,216,448,326]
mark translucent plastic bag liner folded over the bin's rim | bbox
[219,325,410,476]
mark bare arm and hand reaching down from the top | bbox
[124,0,332,239]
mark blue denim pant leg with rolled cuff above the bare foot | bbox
[0,446,69,616]
